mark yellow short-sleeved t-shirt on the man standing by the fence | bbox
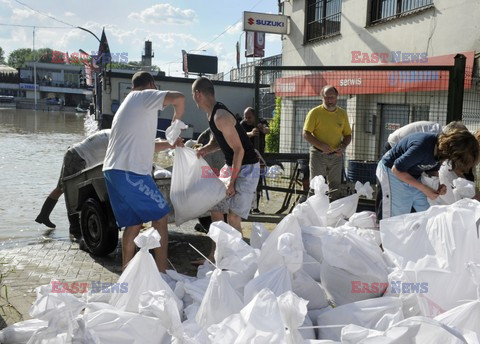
[303,104,352,149]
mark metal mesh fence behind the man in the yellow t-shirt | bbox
[255,55,472,207]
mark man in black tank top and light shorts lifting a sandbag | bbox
[192,77,260,258]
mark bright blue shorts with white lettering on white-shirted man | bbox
[103,170,170,227]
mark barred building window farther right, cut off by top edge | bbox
[370,0,433,24]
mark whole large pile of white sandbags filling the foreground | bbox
[0,177,480,344]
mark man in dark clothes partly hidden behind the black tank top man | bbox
[240,107,270,214]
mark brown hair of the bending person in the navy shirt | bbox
[437,129,480,172]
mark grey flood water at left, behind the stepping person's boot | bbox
[0,109,91,247]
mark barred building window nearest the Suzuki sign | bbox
[306,0,342,42]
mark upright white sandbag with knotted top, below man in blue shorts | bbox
[109,227,183,313]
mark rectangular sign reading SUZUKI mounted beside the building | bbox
[243,12,288,35]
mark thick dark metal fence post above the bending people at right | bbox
[447,54,466,123]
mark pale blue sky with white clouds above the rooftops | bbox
[0,0,281,76]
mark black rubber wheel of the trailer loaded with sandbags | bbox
[80,198,118,256]
